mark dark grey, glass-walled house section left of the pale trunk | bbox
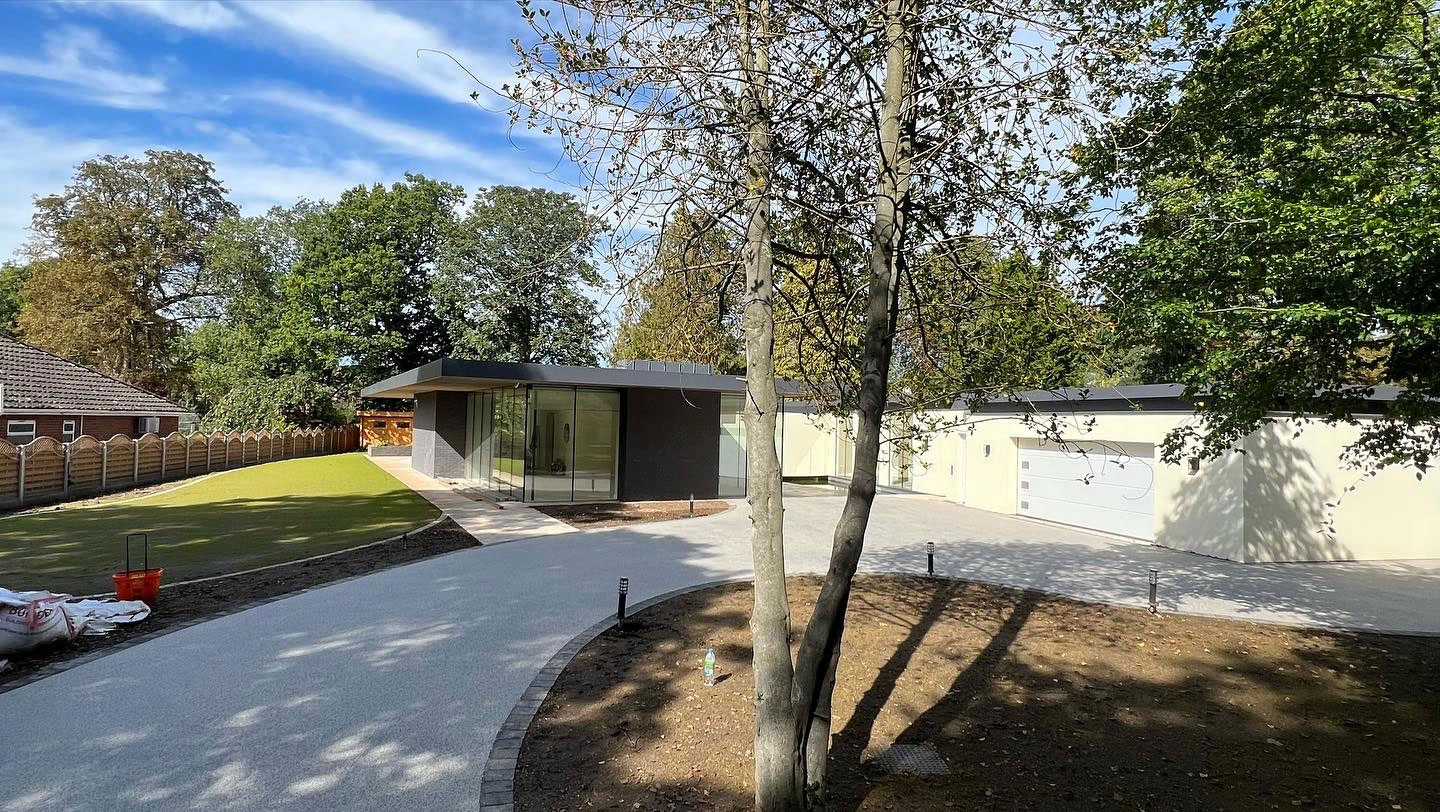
[360,358,806,502]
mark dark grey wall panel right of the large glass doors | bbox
[621,389,720,501]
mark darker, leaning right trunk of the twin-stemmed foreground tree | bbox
[795,0,917,808]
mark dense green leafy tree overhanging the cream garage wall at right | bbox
[1090,0,1440,471]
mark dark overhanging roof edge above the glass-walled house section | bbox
[360,358,802,397]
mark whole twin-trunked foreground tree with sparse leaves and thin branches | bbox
[514,0,1207,809]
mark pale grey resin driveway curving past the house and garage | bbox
[0,497,1440,811]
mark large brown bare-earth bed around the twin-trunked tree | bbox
[516,576,1440,811]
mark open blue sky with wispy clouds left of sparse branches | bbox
[0,0,570,259]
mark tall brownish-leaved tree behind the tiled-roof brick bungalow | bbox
[19,150,236,392]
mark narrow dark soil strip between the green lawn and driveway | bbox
[0,518,480,691]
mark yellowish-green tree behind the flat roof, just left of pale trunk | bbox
[611,212,744,373]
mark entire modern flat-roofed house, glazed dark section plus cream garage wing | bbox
[363,358,1440,561]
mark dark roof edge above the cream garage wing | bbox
[952,383,1404,412]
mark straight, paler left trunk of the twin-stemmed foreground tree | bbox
[739,0,804,812]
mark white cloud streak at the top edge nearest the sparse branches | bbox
[230,0,514,104]
